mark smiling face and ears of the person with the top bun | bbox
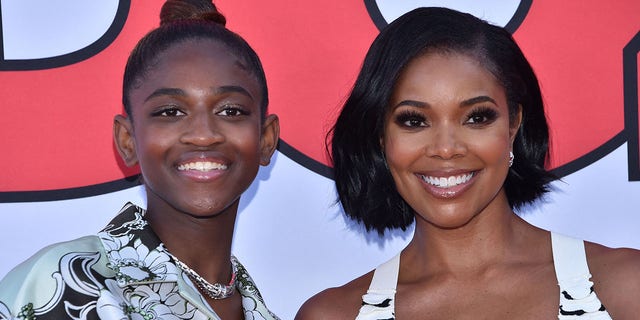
[114,40,278,216]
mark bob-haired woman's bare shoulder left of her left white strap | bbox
[296,271,373,320]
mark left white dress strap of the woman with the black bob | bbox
[356,253,400,320]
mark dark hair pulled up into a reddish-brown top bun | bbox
[122,0,269,120]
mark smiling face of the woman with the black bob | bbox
[381,53,520,228]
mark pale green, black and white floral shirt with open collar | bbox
[0,203,278,320]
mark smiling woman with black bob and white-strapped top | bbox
[297,8,640,319]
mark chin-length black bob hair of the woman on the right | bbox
[328,8,556,234]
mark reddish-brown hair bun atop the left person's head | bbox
[160,0,227,26]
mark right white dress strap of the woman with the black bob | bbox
[551,232,611,320]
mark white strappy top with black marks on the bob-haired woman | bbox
[356,233,611,320]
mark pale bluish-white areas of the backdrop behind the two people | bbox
[0,0,640,319]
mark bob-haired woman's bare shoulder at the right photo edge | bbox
[585,242,640,319]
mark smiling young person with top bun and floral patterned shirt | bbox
[0,0,279,319]
